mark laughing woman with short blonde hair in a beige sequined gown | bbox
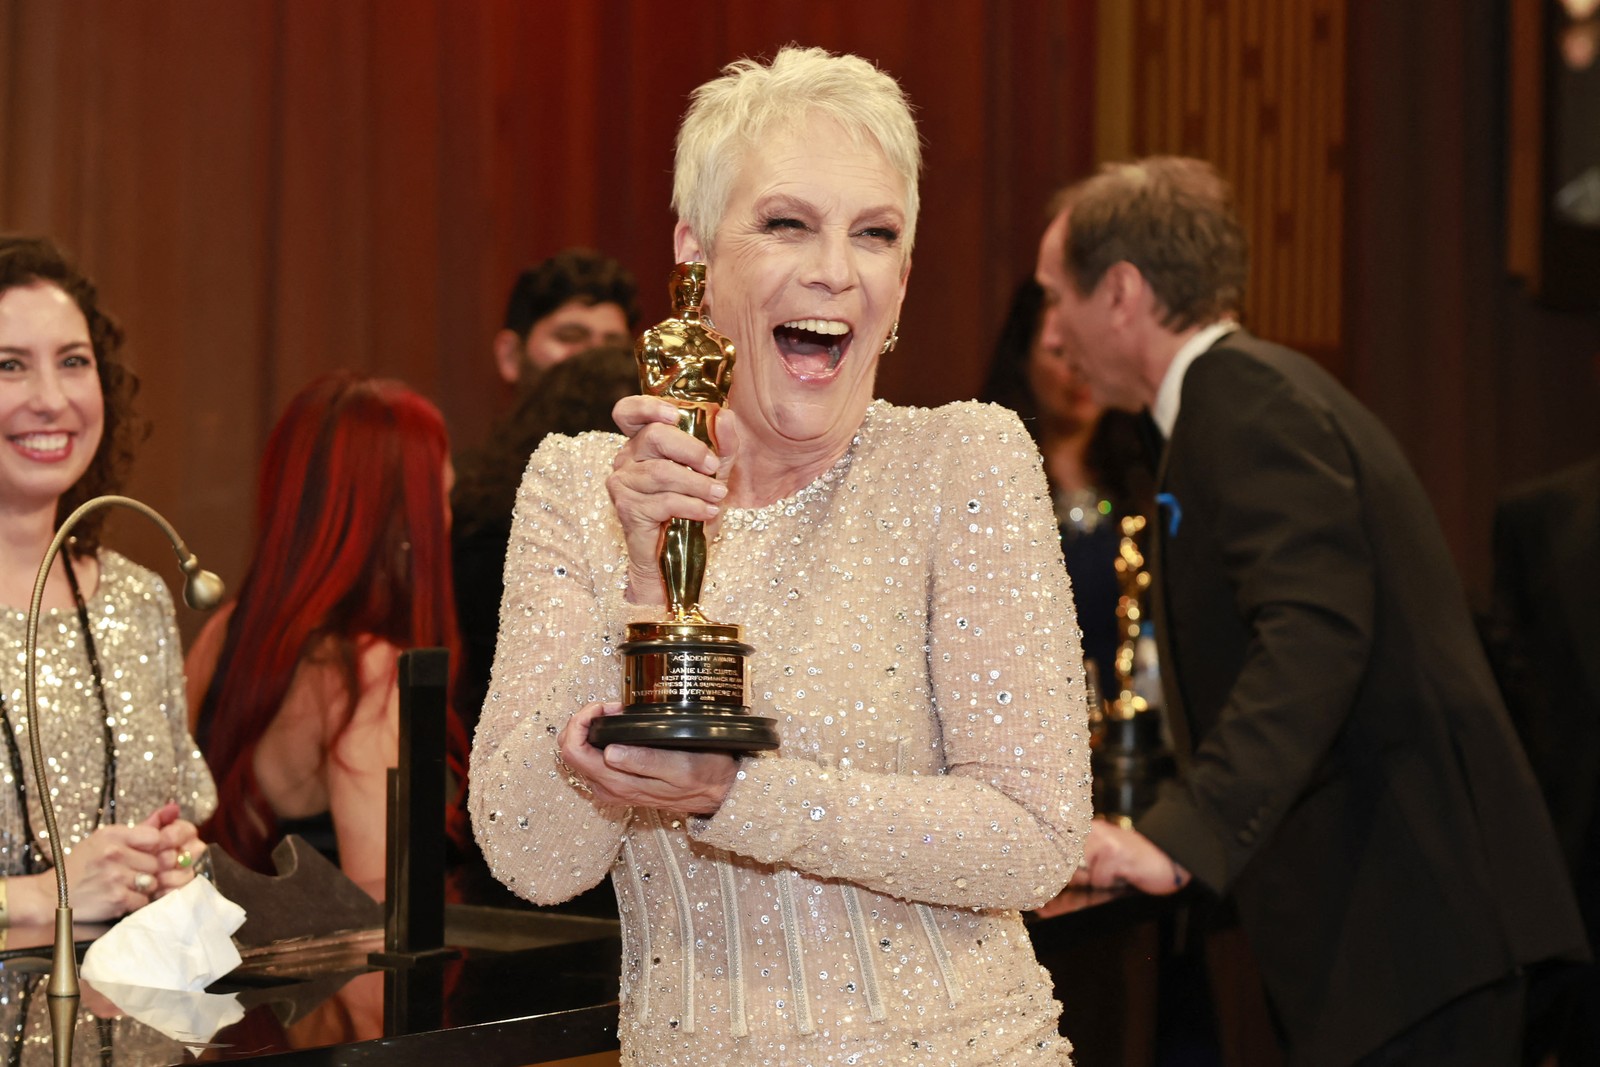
[472,48,1090,1064]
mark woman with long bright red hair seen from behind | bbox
[186,373,466,899]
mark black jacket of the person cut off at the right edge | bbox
[1491,458,1600,947]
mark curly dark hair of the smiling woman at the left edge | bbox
[0,235,149,557]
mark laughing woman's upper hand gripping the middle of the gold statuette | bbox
[606,395,736,605]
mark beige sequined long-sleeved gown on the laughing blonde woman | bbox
[472,402,1090,1067]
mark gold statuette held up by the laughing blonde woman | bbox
[589,262,778,752]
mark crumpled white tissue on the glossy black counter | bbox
[80,878,245,991]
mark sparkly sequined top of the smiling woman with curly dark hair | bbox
[0,549,216,875]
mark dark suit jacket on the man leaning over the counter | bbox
[1138,331,1584,1064]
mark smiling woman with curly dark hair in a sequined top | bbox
[0,237,216,925]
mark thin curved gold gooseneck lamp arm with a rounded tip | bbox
[24,496,226,1062]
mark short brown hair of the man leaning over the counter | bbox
[1058,155,1250,330]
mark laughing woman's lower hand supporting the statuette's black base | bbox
[557,702,739,814]
